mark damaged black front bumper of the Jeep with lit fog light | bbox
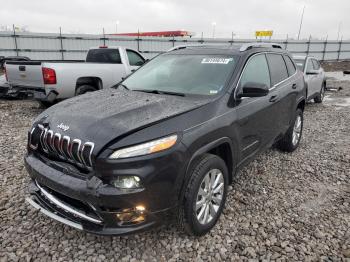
[25,155,170,235]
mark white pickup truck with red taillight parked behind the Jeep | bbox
[5,46,146,106]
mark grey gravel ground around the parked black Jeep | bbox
[0,82,350,261]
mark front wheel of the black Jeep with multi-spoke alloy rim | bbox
[178,154,229,236]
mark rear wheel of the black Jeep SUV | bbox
[277,108,304,152]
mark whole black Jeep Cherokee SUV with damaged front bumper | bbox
[25,43,305,235]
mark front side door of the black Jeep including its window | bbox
[235,54,279,161]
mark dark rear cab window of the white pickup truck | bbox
[86,48,122,64]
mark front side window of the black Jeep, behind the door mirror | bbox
[239,54,271,88]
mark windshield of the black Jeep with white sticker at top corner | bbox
[122,54,237,96]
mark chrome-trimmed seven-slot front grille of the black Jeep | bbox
[28,124,94,170]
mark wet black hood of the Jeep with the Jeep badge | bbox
[37,88,210,153]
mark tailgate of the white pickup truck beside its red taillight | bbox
[5,61,44,88]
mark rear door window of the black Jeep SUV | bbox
[267,54,288,86]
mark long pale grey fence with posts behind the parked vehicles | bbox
[0,30,350,61]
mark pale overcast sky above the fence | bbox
[0,0,350,39]
